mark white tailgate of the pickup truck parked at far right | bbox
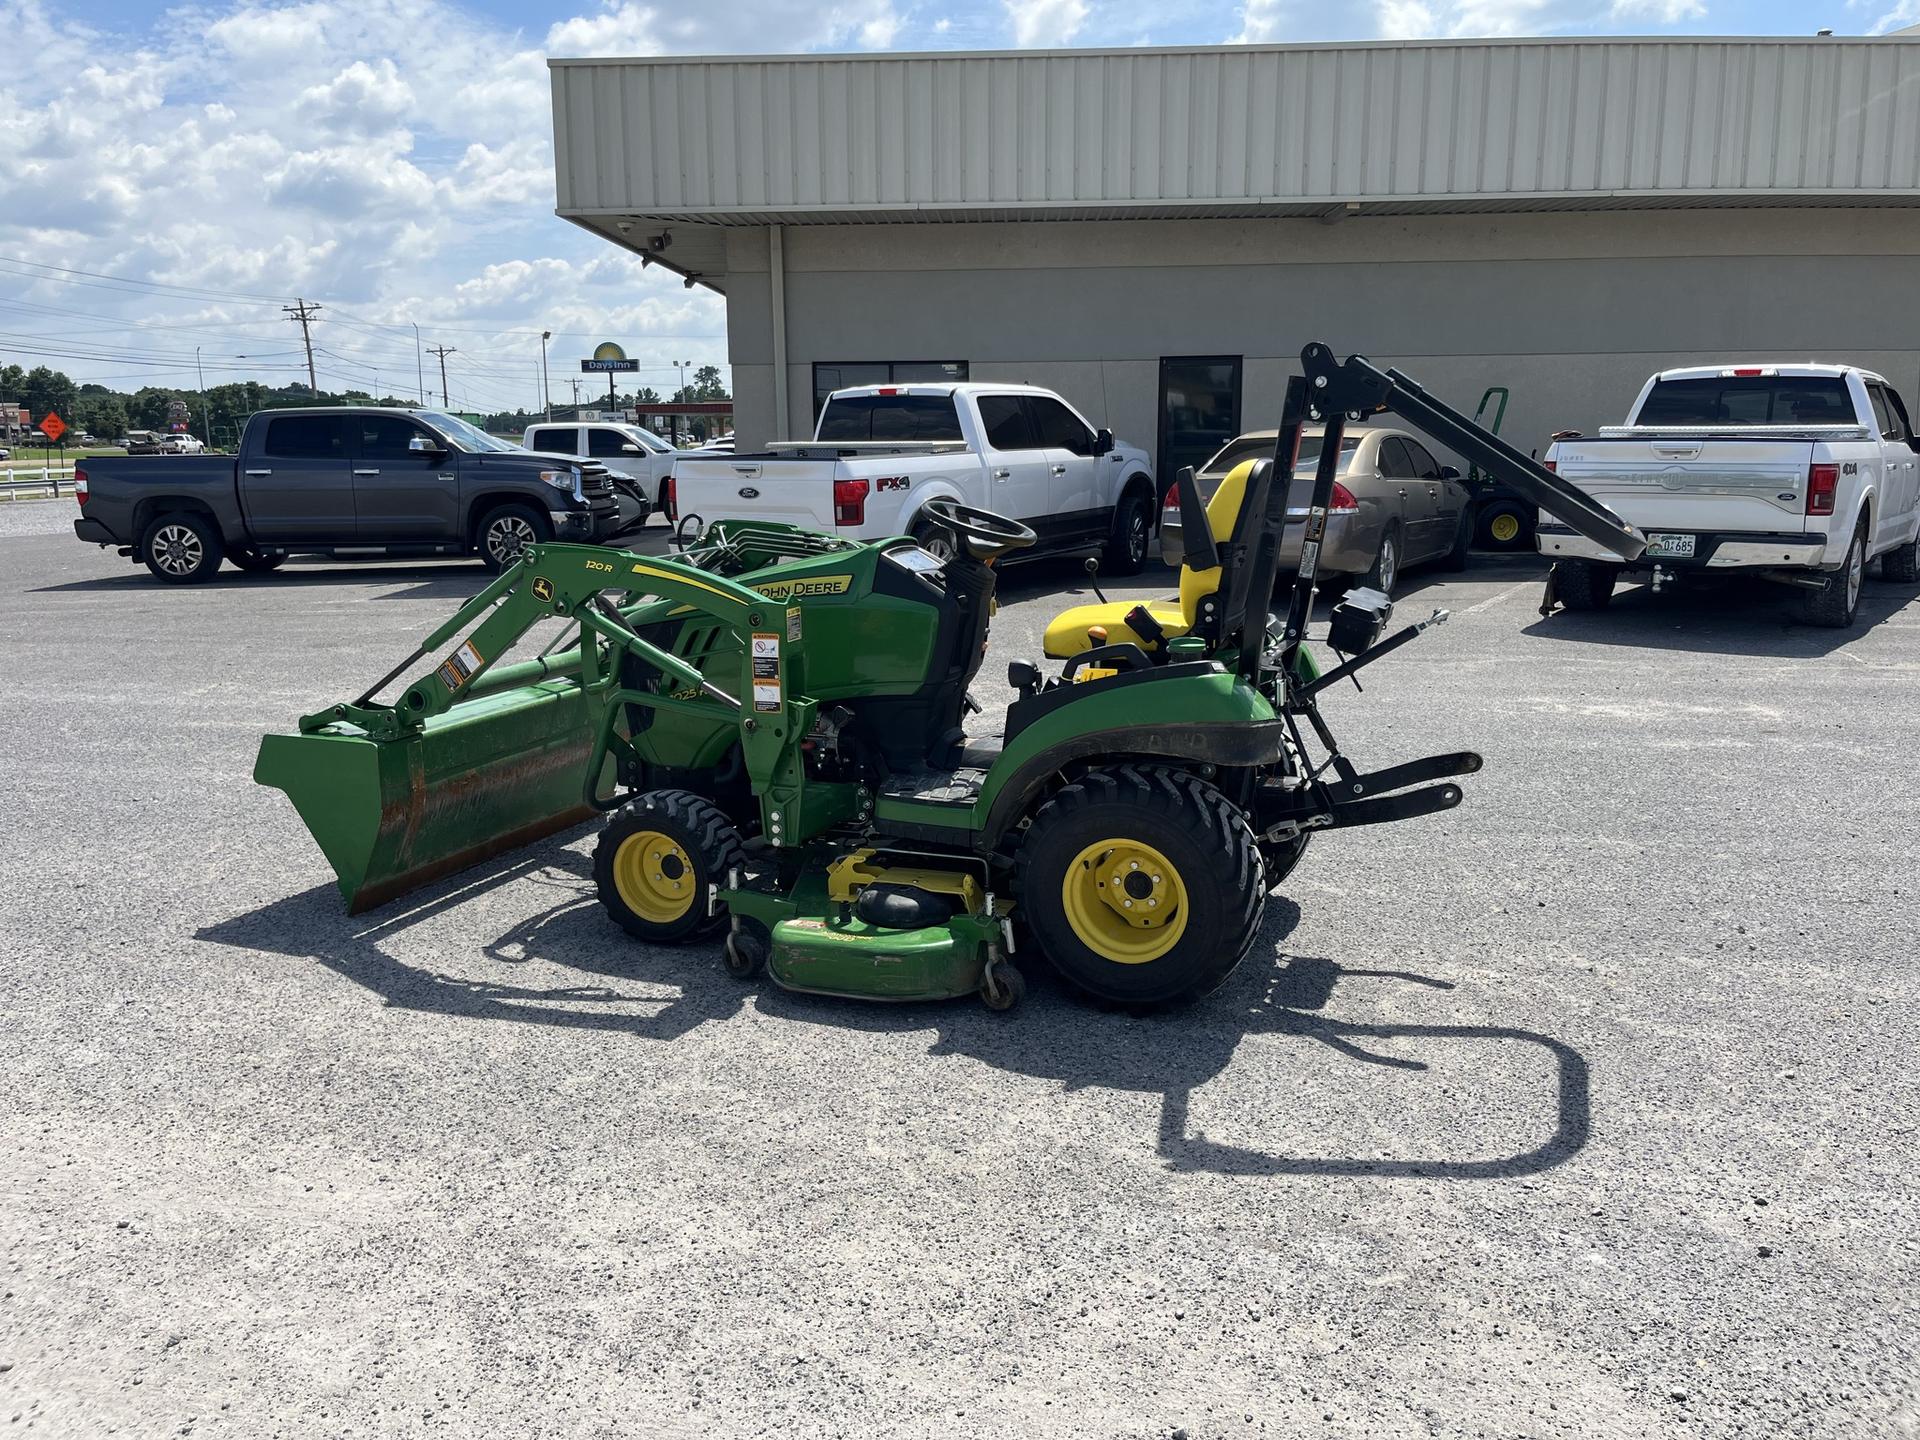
[1553,436,1814,534]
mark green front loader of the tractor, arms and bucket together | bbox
[253,545,824,910]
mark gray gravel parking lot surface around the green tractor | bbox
[0,503,1920,1440]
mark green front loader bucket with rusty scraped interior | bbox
[253,678,605,914]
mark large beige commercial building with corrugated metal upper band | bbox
[551,36,1920,474]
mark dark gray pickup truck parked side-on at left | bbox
[73,407,641,584]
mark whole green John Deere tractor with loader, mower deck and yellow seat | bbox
[253,346,1642,1008]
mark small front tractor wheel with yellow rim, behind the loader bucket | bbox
[593,789,747,945]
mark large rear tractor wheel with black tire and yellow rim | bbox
[1014,764,1267,1010]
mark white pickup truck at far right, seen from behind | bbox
[1538,365,1920,626]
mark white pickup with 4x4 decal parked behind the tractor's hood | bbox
[668,382,1156,574]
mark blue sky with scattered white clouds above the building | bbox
[0,0,1920,409]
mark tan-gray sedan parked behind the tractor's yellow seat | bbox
[1160,426,1473,595]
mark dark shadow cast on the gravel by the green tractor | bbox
[196,852,1590,1179]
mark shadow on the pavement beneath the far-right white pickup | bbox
[1521,578,1916,660]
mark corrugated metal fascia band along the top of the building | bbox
[551,38,1920,225]
